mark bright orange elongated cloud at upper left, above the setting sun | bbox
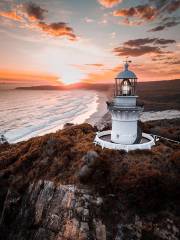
[37,21,77,41]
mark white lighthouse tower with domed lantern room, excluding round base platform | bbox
[107,61,143,144]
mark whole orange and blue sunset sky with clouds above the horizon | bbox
[0,0,180,85]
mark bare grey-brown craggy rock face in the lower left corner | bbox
[0,181,106,240]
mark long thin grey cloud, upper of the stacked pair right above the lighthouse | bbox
[124,38,176,47]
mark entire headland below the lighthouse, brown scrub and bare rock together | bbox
[0,119,180,240]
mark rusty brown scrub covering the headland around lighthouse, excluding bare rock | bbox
[0,120,180,211]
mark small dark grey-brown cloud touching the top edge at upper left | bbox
[24,2,48,20]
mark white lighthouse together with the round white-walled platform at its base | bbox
[94,61,155,151]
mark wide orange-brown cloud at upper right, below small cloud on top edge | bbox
[113,4,157,21]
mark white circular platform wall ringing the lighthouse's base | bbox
[94,130,155,152]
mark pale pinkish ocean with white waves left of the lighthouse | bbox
[0,90,98,143]
